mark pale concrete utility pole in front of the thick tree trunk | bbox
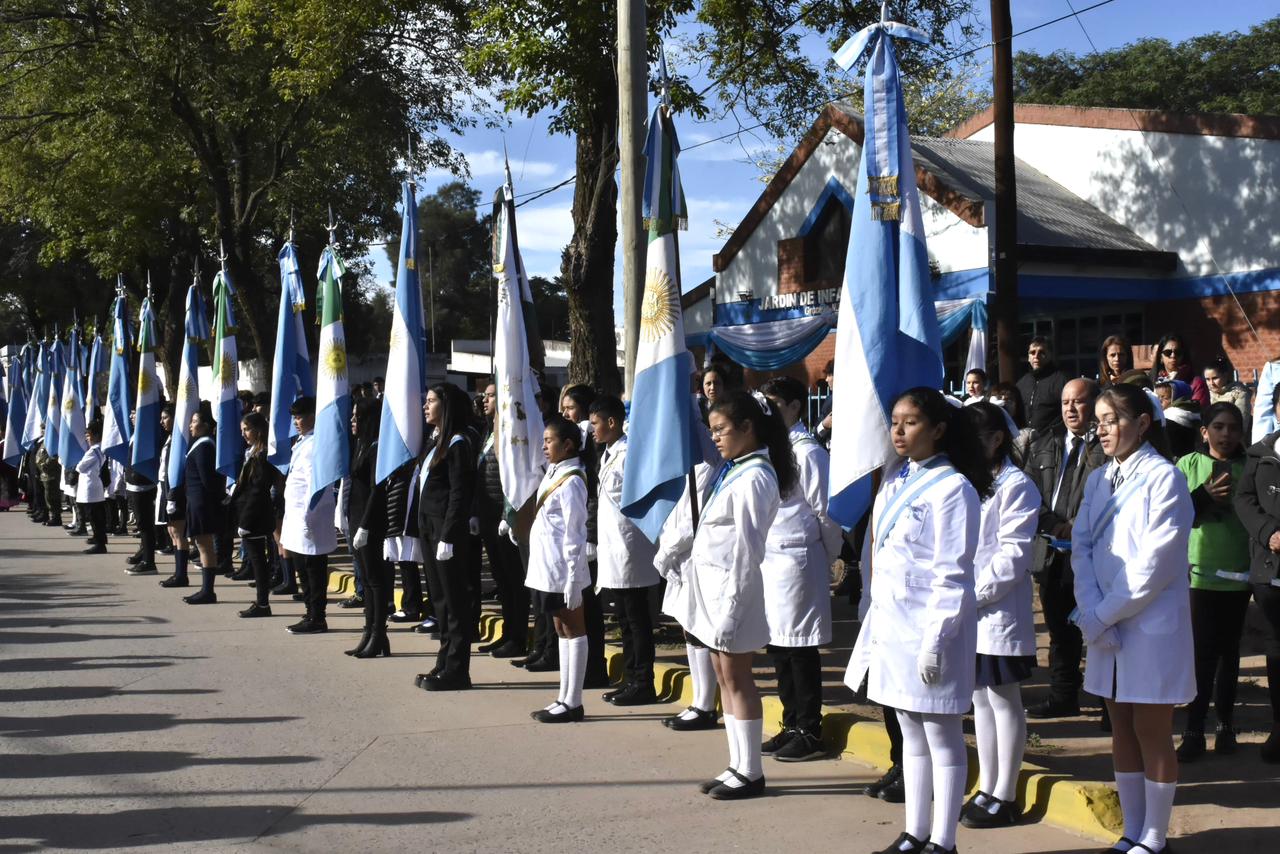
[611,0,649,396]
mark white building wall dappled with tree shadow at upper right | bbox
[972,123,1280,275]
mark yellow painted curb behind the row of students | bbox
[329,571,1124,842]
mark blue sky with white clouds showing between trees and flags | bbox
[370,0,1277,323]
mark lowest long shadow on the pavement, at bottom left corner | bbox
[5,804,471,850]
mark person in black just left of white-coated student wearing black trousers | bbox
[232,412,284,617]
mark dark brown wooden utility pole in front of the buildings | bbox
[987,0,1018,383]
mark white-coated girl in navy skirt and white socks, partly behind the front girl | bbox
[960,402,1041,827]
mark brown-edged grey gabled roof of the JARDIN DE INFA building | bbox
[712,101,1178,273]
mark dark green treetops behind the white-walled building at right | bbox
[1014,18,1280,115]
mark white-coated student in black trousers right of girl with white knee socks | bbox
[590,394,660,705]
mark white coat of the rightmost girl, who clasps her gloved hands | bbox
[1071,444,1196,704]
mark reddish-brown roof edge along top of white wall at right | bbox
[947,104,1280,140]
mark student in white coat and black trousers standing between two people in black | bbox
[276,397,338,635]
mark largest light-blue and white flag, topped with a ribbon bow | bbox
[828,20,942,528]
